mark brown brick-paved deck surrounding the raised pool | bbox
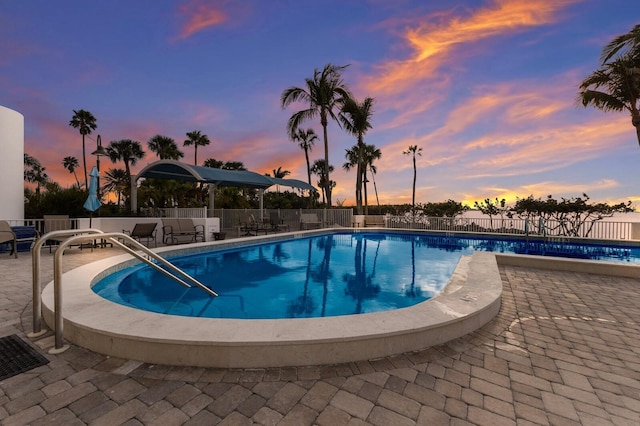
[0,248,640,426]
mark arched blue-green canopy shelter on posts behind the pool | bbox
[131,160,316,213]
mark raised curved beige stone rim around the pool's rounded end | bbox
[42,230,502,368]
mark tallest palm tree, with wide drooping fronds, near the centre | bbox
[280,64,351,206]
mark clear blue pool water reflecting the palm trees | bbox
[93,232,640,319]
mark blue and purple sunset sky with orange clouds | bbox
[0,0,640,208]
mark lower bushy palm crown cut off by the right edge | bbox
[578,56,640,144]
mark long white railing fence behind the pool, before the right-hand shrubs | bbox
[386,215,634,240]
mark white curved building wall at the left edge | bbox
[0,105,24,220]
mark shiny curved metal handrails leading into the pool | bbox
[28,229,218,354]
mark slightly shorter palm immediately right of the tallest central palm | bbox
[339,98,373,214]
